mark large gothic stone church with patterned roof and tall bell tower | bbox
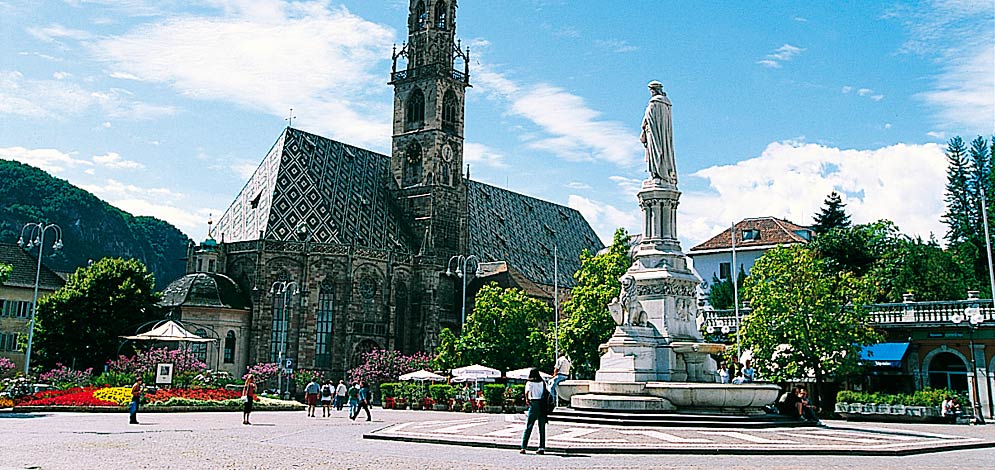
[161,0,603,376]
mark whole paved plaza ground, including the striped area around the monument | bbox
[0,409,995,470]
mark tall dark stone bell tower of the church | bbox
[390,0,470,263]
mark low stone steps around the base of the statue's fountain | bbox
[549,408,815,429]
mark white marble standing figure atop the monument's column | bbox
[639,80,677,185]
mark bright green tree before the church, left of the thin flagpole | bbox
[458,282,553,370]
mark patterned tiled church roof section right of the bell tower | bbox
[466,180,604,286]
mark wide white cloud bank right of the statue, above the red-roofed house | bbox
[679,142,946,243]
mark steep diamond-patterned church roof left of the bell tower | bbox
[214,128,411,249]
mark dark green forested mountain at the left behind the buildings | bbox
[0,160,190,289]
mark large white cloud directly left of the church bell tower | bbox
[90,0,394,146]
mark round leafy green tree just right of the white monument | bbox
[740,245,879,408]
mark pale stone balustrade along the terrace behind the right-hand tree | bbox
[698,299,995,333]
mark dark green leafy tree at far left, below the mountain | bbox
[34,258,159,369]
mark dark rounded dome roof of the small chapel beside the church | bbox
[159,273,249,309]
